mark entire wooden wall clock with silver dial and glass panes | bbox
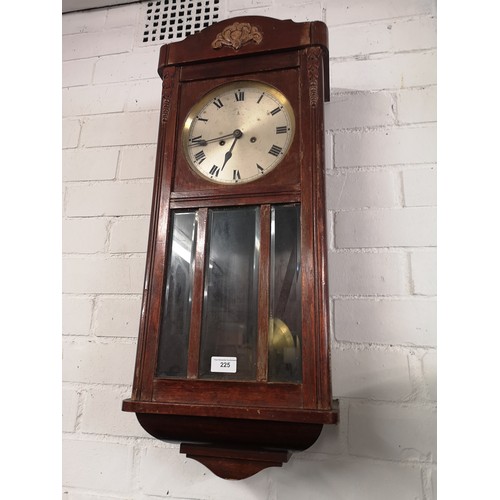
[123,16,337,479]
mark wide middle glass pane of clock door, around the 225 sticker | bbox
[199,207,260,380]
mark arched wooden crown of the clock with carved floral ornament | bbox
[158,16,330,101]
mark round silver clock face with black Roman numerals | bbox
[182,81,295,184]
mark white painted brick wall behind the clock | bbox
[62,0,437,500]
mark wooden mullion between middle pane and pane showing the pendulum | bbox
[257,205,271,382]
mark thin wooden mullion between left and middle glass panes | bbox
[187,208,208,379]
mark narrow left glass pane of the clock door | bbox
[157,211,196,377]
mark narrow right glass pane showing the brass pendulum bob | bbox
[268,204,302,382]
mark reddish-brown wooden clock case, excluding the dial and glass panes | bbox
[123,16,337,479]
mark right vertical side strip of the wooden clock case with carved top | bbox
[301,46,336,410]
